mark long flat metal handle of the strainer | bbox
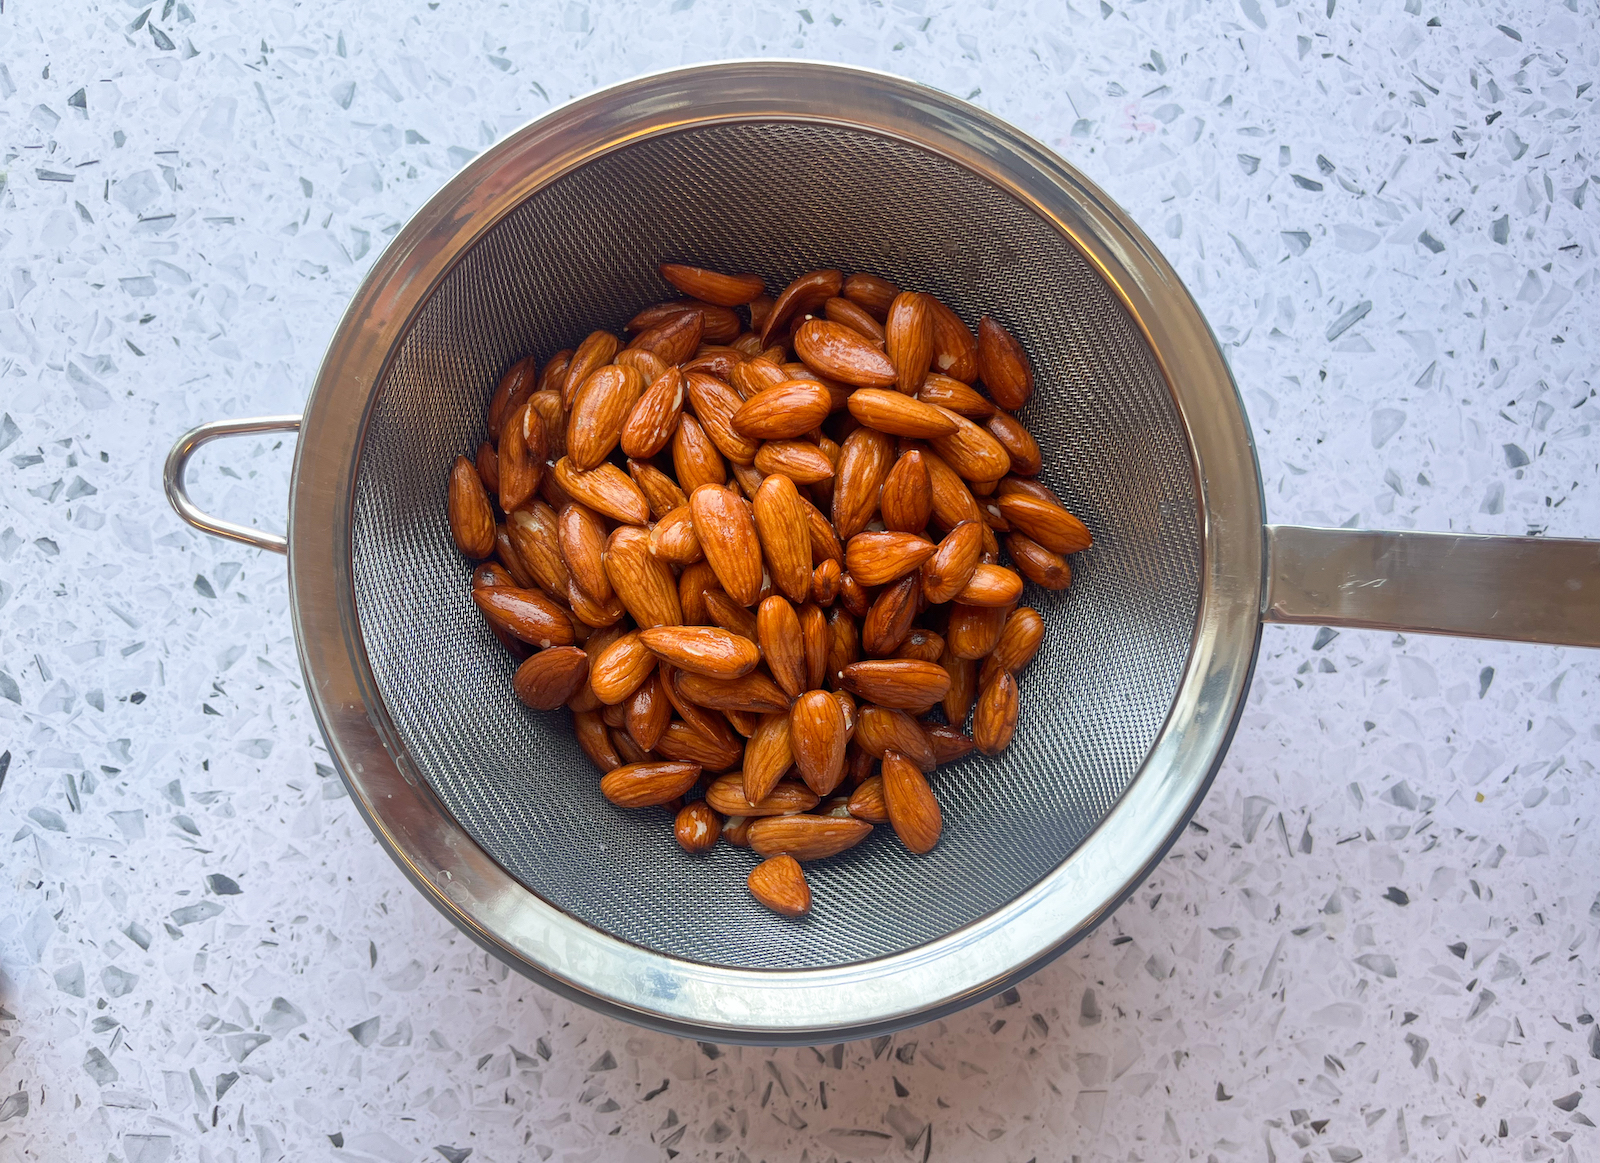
[1262,525,1600,646]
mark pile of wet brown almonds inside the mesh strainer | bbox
[450,262,1091,917]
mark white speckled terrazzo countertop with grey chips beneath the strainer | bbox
[0,0,1600,1163]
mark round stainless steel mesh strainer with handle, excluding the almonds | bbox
[166,61,1600,1043]
